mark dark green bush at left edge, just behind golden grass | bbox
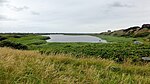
[0,41,28,50]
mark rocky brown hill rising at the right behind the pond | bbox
[100,24,150,38]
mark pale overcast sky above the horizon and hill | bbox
[0,0,150,32]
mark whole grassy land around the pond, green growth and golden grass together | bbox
[0,34,150,84]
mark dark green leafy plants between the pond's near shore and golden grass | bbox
[35,43,150,62]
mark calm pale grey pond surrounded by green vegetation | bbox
[45,35,107,43]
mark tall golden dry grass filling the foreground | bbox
[0,48,150,84]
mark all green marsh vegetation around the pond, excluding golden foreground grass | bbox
[0,35,150,62]
